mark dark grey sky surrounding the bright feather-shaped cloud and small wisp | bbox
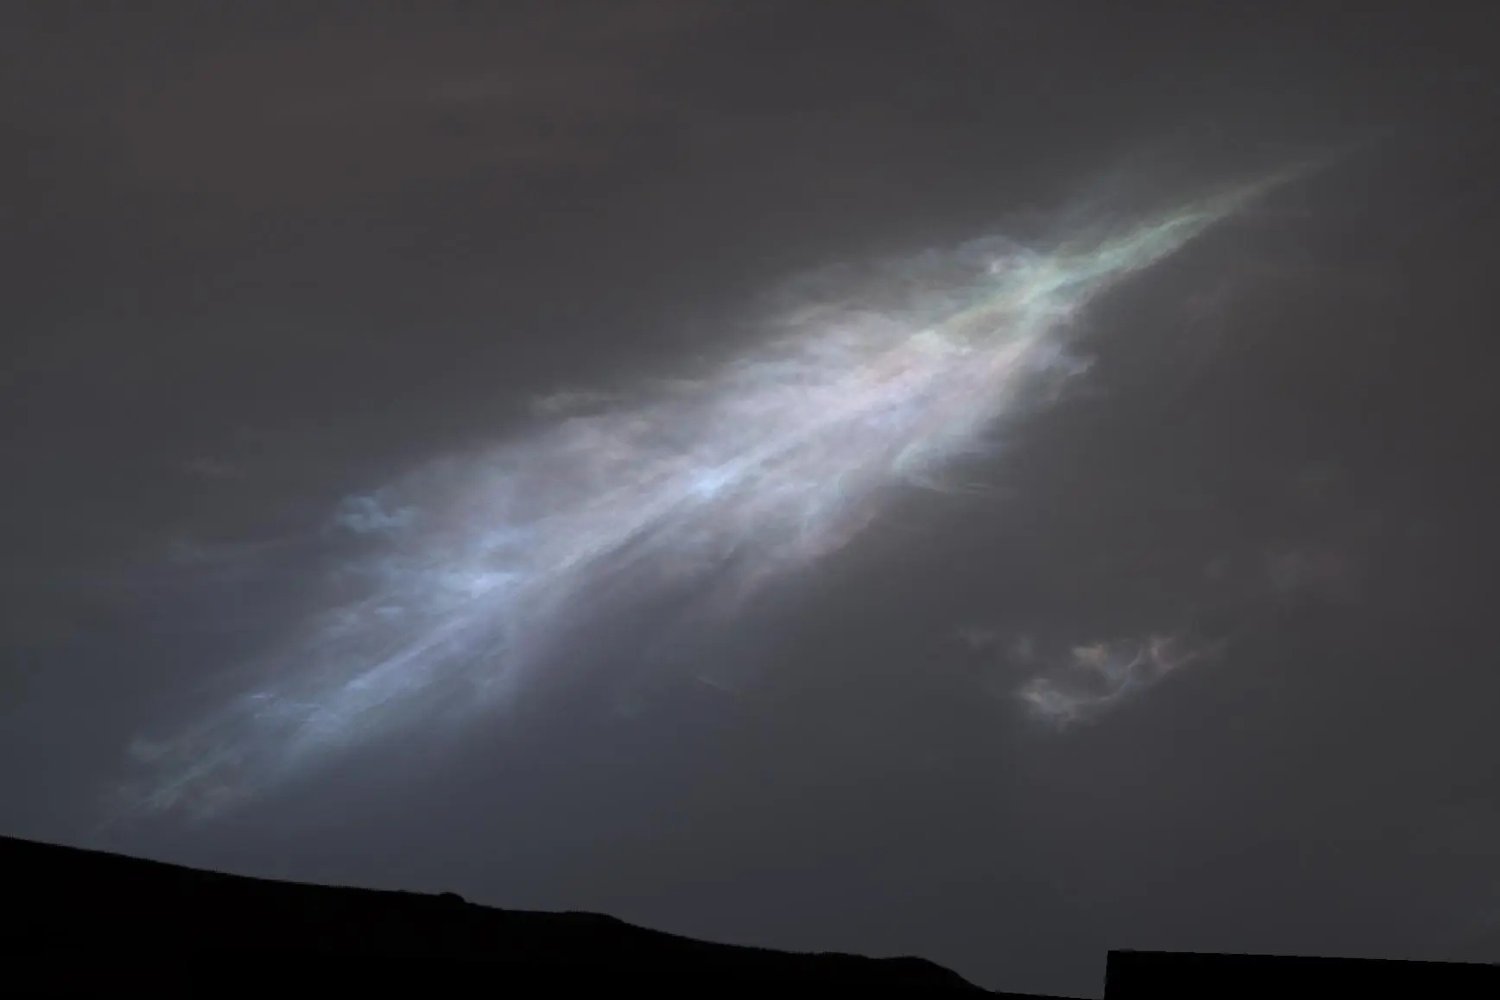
[0,0,1500,996]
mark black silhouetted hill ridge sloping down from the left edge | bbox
[0,838,1032,996]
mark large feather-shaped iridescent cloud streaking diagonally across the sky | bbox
[122,181,1274,816]
